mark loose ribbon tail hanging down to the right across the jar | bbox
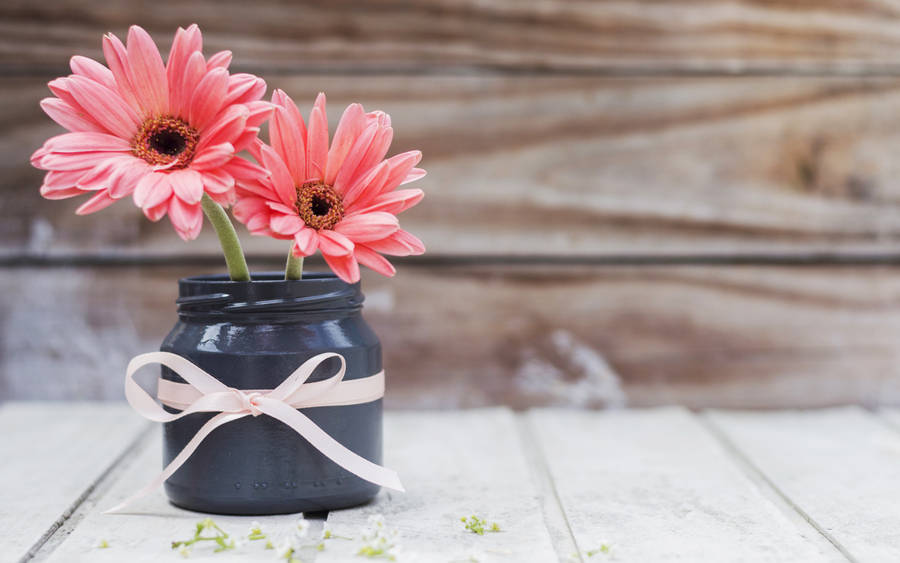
[259,399,406,492]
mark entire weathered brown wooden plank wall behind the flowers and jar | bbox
[0,0,900,407]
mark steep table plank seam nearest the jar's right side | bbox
[516,413,584,562]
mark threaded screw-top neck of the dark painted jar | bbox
[176,272,365,323]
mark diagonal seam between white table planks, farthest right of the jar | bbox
[694,411,859,563]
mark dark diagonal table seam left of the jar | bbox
[18,423,154,563]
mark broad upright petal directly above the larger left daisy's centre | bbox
[127,25,169,114]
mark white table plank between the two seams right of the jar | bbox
[529,409,845,562]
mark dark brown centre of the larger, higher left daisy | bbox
[131,116,200,168]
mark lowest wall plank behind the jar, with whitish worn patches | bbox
[0,265,900,408]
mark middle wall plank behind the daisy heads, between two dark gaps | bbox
[8,74,900,256]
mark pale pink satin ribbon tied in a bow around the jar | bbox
[106,352,404,512]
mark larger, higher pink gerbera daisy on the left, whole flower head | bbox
[31,25,271,240]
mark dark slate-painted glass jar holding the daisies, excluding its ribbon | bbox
[160,273,382,515]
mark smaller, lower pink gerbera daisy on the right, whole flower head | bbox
[234,90,425,283]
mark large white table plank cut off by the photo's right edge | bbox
[708,408,900,562]
